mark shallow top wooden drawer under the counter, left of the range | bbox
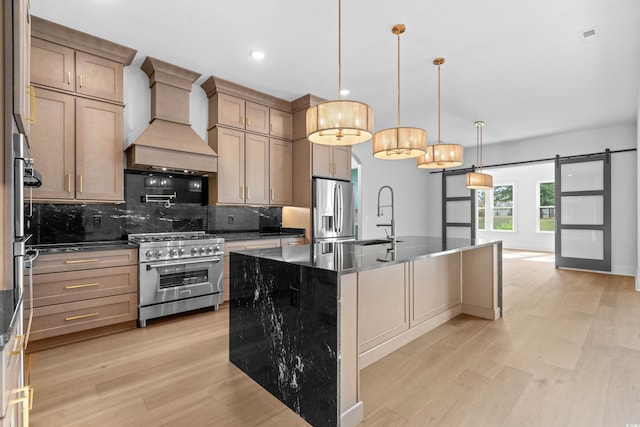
[33,249,138,275]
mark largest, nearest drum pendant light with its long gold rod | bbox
[307,0,373,145]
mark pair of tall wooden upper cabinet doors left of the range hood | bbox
[31,87,124,202]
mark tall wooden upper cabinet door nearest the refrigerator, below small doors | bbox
[269,139,293,205]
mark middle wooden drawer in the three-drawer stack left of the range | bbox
[25,265,138,307]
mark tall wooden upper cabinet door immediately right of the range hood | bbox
[214,128,245,204]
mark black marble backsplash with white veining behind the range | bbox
[25,173,282,244]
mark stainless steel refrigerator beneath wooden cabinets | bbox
[312,178,355,243]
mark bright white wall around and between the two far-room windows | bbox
[476,162,555,252]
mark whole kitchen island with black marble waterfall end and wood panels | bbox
[229,236,502,426]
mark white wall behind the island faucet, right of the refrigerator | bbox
[352,142,430,239]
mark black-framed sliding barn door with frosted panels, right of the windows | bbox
[556,150,611,271]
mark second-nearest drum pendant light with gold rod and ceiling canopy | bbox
[373,24,427,160]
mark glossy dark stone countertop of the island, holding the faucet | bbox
[232,236,501,273]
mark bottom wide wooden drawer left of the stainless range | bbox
[25,294,138,341]
